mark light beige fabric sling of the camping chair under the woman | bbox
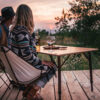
[0,47,41,84]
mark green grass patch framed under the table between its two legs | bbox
[62,54,88,70]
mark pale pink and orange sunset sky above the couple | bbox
[0,0,69,30]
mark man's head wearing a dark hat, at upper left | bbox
[1,7,15,24]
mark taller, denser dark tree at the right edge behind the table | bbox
[70,0,100,47]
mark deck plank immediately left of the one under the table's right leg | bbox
[64,71,88,100]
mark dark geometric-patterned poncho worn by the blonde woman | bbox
[10,26,47,70]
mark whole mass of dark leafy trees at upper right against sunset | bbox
[56,0,100,48]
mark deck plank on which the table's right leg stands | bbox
[74,71,100,100]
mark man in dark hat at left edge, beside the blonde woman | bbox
[0,7,15,46]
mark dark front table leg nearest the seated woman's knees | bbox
[58,56,61,100]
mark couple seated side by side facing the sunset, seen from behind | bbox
[0,4,56,100]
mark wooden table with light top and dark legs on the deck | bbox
[38,46,98,100]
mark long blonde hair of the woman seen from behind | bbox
[14,4,34,33]
